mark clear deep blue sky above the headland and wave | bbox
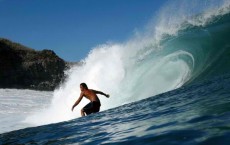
[0,0,165,62]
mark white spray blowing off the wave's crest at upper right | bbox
[150,0,230,41]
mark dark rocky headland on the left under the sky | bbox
[0,39,68,90]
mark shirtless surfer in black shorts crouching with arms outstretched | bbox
[72,83,109,116]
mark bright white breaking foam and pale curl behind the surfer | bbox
[23,42,194,125]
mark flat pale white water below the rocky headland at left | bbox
[0,89,53,133]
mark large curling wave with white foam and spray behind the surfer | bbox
[25,1,230,125]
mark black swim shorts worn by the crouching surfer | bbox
[83,101,101,115]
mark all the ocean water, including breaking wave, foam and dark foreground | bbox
[0,0,230,145]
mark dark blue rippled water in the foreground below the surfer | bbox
[0,75,230,145]
